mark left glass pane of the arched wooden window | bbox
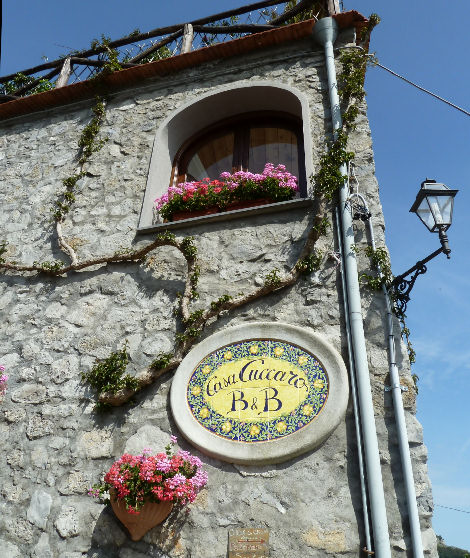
[186,132,235,181]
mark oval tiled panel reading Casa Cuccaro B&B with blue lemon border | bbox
[187,339,328,442]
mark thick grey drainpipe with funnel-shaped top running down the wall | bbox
[313,17,391,558]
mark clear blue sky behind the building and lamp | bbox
[0,0,470,549]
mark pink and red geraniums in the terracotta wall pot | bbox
[88,437,207,513]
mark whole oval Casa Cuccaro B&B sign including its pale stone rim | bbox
[171,322,349,464]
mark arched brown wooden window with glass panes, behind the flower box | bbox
[171,111,306,195]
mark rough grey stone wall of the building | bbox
[0,31,437,558]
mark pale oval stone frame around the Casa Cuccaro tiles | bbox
[171,322,349,464]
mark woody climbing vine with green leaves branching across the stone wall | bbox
[0,14,390,408]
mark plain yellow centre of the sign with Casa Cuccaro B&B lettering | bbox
[203,356,309,421]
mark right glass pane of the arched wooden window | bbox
[248,127,299,177]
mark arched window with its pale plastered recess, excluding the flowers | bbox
[138,80,314,233]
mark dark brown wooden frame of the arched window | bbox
[170,111,307,198]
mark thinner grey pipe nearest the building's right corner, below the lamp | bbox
[354,189,423,558]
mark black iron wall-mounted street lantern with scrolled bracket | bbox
[390,178,458,314]
